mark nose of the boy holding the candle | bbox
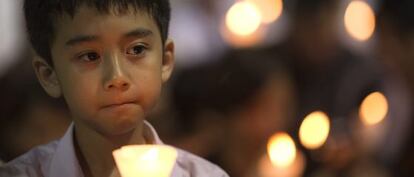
[103,53,131,91]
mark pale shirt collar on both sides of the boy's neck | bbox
[47,121,164,177]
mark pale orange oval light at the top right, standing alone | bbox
[345,0,375,41]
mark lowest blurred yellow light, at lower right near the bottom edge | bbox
[267,133,296,168]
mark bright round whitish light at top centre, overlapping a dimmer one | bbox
[226,1,262,36]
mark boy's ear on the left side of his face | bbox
[32,55,62,98]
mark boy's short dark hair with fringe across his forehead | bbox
[23,0,171,65]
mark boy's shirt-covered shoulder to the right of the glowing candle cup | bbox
[172,148,228,177]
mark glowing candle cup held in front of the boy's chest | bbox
[113,145,177,177]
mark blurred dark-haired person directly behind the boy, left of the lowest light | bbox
[172,49,295,177]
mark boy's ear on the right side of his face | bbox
[161,39,175,82]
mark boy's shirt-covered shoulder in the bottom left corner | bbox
[0,141,58,177]
